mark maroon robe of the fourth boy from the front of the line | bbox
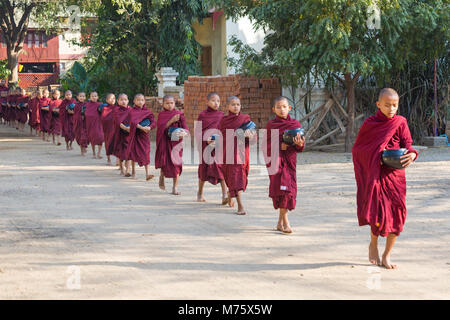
[196,107,224,185]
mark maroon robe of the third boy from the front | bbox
[219,112,251,197]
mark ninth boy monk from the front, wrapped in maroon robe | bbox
[85,92,105,159]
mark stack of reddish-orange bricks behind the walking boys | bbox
[184,75,281,133]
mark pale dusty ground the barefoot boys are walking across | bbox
[0,126,450,299]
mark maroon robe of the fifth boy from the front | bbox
[155,109,189,178]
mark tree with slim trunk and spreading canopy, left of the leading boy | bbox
[211,0,448,152]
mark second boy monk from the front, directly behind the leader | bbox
[263,97,305,233]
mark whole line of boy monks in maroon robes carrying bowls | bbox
[0,84,418,269]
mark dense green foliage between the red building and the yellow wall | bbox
[68,0,207,96]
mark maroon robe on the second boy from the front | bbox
[263,115,304,210]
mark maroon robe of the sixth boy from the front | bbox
[127,106,156,167]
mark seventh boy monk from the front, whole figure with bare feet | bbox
[113,93,131,176]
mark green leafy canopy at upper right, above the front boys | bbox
[214,0,450,137]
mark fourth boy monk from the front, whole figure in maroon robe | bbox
[196,92,228,204]
